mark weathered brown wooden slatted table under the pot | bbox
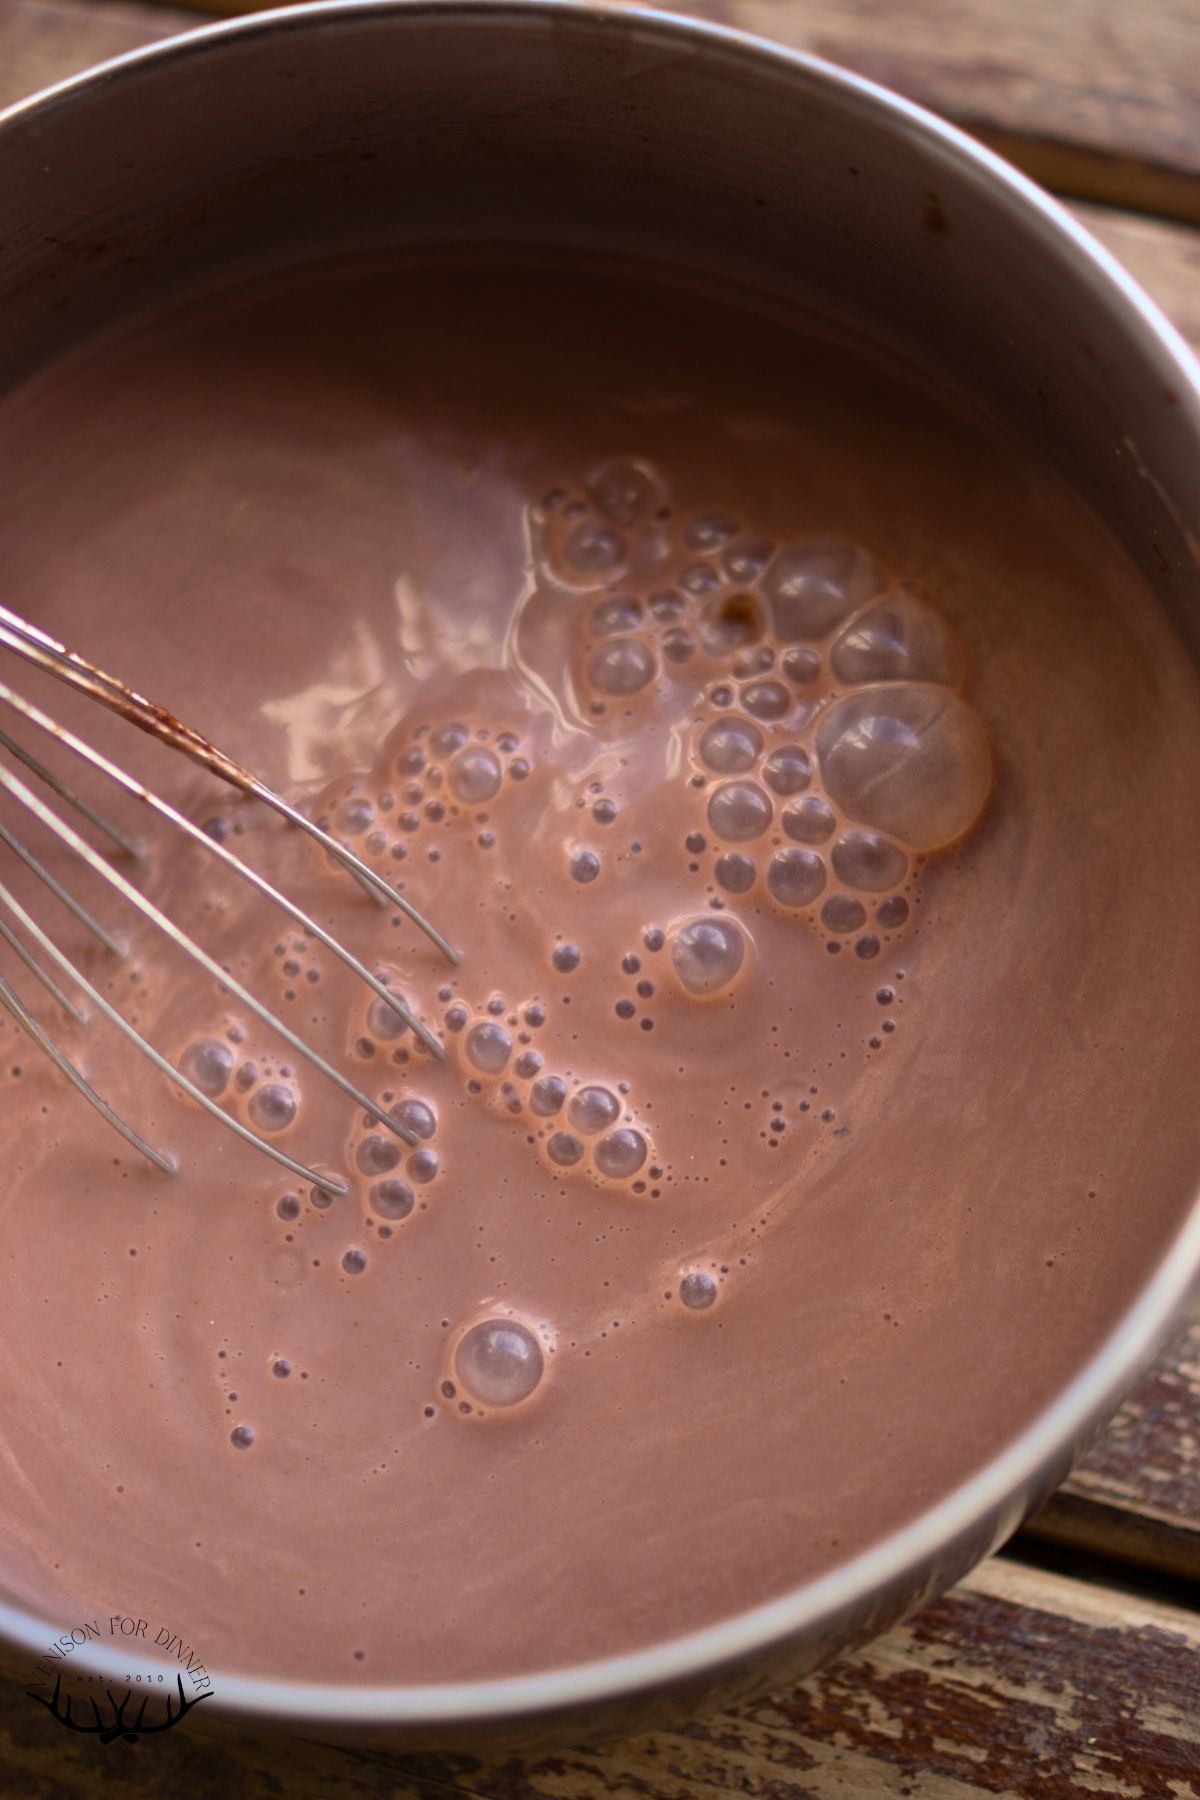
[0,0,1200,1800]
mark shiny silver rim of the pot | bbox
[0,0,1200,1728]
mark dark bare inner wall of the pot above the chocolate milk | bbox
[0,4,1200,652]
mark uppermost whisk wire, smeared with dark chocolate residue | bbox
[0,607,462,965]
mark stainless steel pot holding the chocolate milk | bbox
[0,0,1200,1746]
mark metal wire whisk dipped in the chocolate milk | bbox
[0,607,461,1192]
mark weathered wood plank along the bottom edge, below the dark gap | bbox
[0,1559,1200,1800]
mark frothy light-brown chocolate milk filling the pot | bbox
[0,256,1200,1681]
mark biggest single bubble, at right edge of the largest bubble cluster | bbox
[817,686,991,850]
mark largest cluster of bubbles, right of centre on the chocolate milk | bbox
[534,459,991,972]
